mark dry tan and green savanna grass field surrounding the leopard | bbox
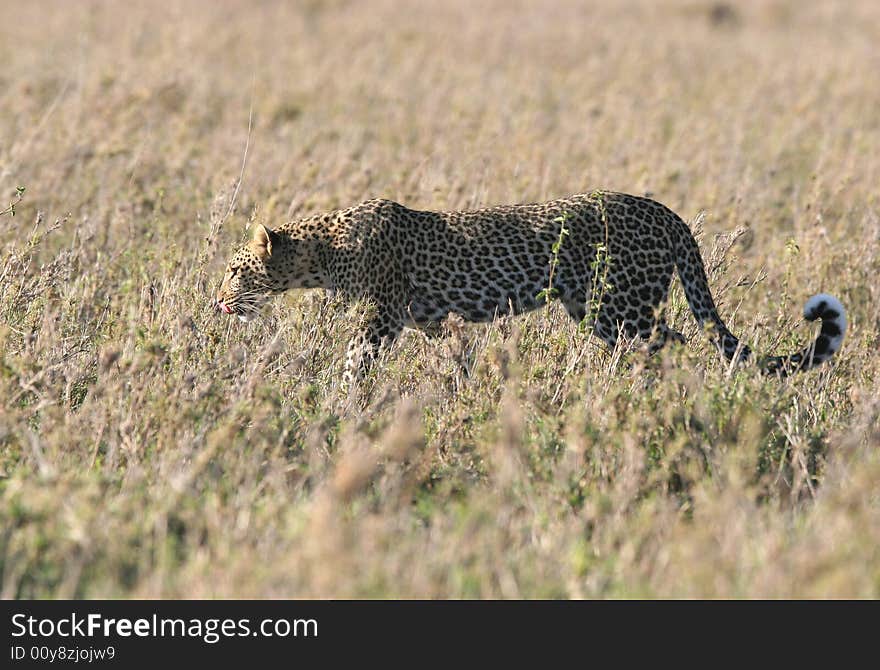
[0,0,880,599]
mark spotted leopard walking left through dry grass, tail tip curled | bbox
[213,190,847,385]
